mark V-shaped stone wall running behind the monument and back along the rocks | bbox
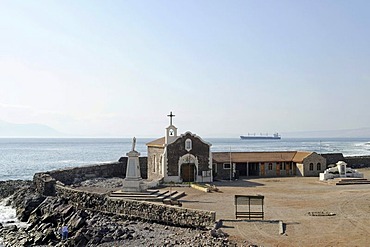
[33,157,216,229]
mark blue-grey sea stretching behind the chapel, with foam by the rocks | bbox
[0,138,370,231]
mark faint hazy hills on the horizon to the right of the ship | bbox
[281,128,370,138]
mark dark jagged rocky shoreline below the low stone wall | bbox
[0,181,236,246]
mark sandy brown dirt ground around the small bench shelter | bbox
[176,169,370,246]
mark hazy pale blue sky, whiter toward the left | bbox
[0,0,370,137]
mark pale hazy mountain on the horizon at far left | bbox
[0,121,63,137]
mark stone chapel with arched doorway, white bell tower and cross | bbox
[146,112,213,183]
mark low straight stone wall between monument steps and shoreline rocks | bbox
[56,185,216,229]
